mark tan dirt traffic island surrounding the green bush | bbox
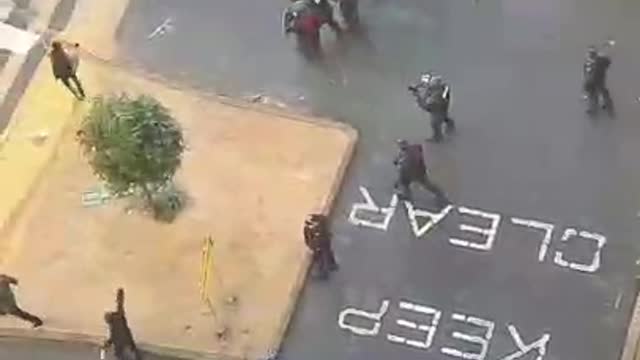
[0,54,357,359]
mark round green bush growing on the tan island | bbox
[77,94,185,221]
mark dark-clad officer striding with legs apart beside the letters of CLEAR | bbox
[393,140,449,207]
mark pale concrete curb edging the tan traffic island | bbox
[0,52,358,360]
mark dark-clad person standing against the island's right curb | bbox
[303,214,338,279]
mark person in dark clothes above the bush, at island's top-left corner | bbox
[49,41,85,100]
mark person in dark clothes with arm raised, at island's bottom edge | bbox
[102,288,142,360]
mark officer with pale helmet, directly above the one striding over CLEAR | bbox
[409,74,455,142]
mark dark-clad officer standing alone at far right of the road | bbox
[583,46,613,114]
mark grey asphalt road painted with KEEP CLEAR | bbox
[0,0,640,360]
